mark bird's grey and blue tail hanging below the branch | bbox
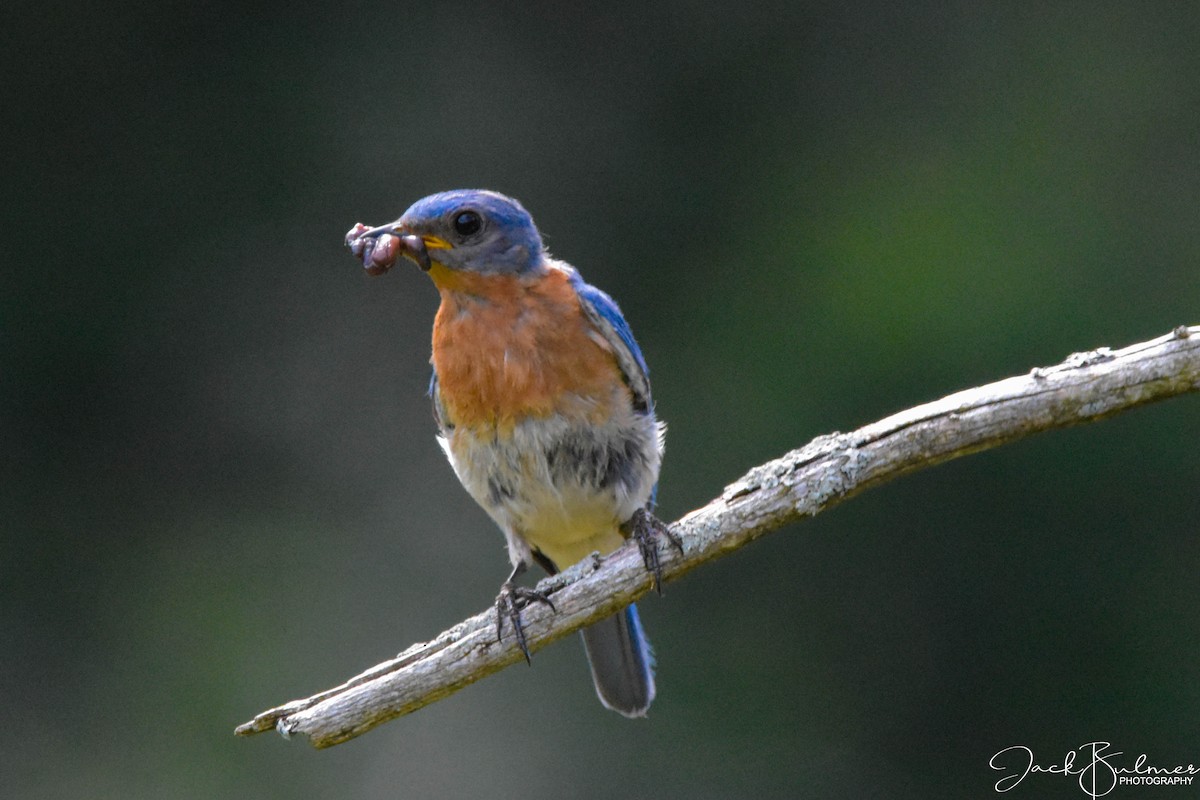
[582,606,654,717]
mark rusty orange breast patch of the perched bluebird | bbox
[432,267,628,428]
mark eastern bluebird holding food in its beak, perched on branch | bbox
[346,190,678,717]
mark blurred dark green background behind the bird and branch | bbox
[0,0,1200,799]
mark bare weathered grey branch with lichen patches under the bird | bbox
[236,326,1200,747]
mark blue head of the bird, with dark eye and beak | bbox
[388,190,544,275]
